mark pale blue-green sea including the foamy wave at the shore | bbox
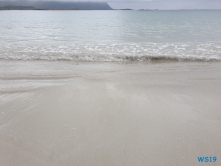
[0,10,221,61]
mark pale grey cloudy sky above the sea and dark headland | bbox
[0,0,221,9]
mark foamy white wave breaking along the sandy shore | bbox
[0,43,221,62]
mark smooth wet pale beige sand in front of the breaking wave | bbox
[0,61,221,166]
